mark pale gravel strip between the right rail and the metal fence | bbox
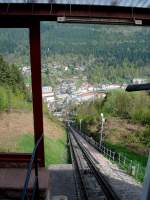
[68,126,142,200]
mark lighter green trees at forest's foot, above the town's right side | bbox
[87,59,148,84]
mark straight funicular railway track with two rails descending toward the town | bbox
[68,125,119,200]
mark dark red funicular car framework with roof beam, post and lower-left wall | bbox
[0,0,150,200]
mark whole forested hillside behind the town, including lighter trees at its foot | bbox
[0,22,150,84]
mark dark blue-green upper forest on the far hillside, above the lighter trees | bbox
[0,22,150,65]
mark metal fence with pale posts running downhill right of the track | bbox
[80,132,145,182]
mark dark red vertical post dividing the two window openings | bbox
[29,20,45,166]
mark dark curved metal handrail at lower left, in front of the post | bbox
[21,135,43,200]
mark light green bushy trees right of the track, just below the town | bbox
[73,90,150,125]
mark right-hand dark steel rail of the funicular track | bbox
[70,127,120,200]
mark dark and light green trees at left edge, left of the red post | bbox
[0,56,31,112]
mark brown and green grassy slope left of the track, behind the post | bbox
[0,112,68,166]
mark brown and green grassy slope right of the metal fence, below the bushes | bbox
[105,117,149,166]
